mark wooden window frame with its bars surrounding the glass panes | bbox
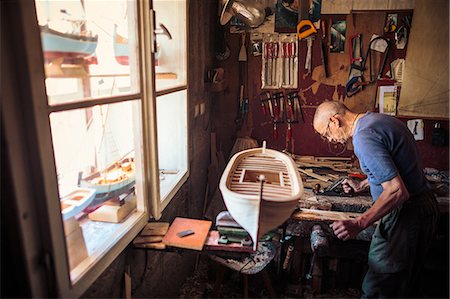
[5,0,190,297]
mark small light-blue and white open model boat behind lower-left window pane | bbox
[60,188,95,220]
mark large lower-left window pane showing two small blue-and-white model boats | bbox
[50,100,143,279]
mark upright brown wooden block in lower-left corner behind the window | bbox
[64,217,88,270]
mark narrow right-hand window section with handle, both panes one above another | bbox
[152,0,189,218]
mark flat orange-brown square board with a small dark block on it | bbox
[163,217,212,250]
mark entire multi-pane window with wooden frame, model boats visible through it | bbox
[10,0,189,297]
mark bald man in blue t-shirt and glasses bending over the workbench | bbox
[313,101,439,298]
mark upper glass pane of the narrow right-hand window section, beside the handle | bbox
[153,0,187,91]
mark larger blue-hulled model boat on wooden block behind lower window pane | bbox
[79,156,135,213]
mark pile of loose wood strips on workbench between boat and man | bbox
[293,156,361,188]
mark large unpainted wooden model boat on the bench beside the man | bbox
[219,142,303,250]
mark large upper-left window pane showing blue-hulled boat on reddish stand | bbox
[35,0,139,105]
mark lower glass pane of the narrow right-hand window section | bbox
[156,90,188,200]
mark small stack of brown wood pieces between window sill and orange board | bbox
[133,222,169,249]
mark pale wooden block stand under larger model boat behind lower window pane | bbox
[89,198,136,223]
